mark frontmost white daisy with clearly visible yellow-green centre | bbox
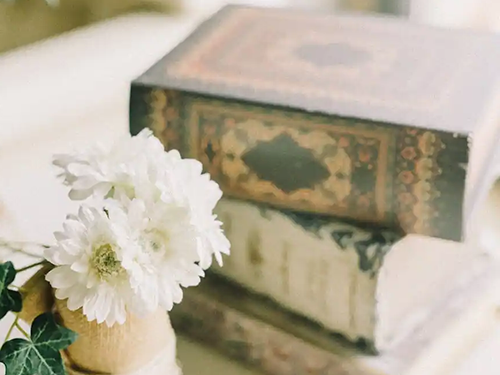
[45,206,142,326]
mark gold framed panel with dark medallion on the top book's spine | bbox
[185,99,394,222]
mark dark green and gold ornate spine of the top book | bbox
[130,84,469,240]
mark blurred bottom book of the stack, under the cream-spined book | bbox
[171,267,500,375]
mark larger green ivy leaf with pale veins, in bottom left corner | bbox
[0,313,77,375]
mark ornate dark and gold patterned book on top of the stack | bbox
[130,6,500,241]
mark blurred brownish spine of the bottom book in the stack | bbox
[170,289,374,375]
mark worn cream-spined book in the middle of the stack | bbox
[212,198,491,351]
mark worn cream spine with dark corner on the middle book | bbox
[214,198,400,347]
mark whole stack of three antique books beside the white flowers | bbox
[126,6,500,375]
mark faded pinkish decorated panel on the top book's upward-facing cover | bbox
[161,8,478,118]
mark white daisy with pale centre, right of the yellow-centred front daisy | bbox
[115,199,204,311]
